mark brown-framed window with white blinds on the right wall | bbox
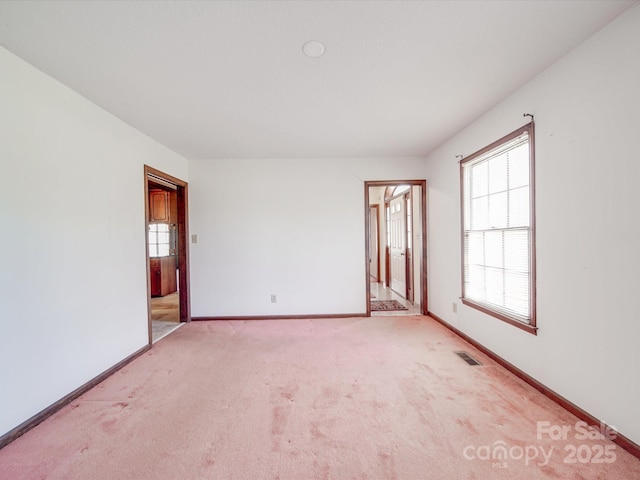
[460,122,536,334]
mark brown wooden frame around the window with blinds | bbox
[459,121,538,335]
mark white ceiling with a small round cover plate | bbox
[0,0,636,158]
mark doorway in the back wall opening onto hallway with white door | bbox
[365,180,428,316]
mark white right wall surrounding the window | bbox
[427,8,640,443]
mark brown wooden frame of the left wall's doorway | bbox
[144,165,191,345]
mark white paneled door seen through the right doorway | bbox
[389,196,407,297]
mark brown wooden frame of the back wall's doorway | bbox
[364,180,429,317]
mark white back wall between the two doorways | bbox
[189,158,424,317]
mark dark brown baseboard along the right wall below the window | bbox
[428,312,640,459]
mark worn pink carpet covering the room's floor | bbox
[0,316,640,480]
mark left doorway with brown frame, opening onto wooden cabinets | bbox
[144,165,191,344]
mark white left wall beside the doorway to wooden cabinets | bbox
[0,48,187,435]
